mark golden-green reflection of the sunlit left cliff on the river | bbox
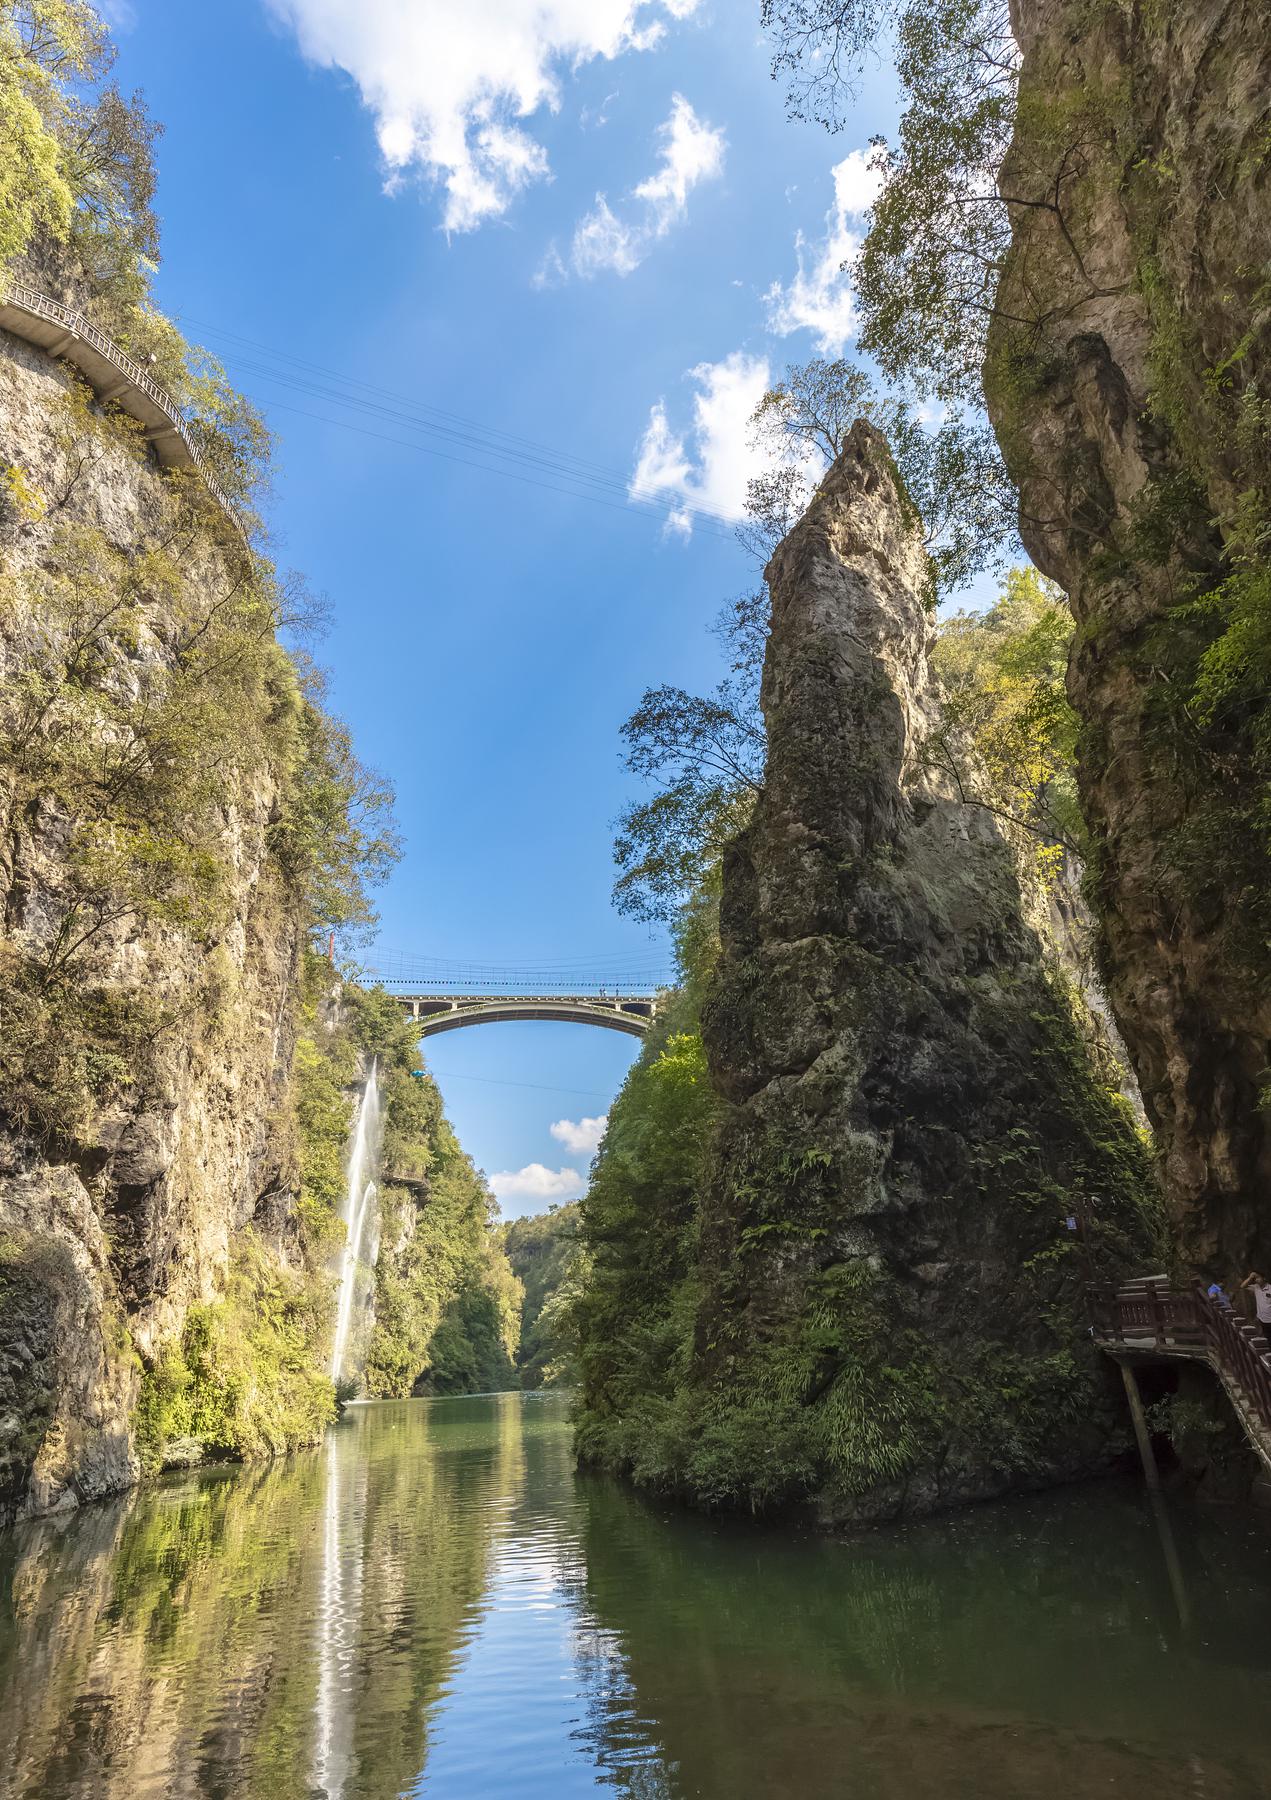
[0,1406,520,1800]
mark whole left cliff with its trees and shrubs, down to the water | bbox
[0,0,518,1519]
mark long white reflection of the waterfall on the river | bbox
[313,1436,365,1800]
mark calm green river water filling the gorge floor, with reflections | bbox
[0,1395,1271,1800]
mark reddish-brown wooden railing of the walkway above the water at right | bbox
[1091,1280,1271,1435]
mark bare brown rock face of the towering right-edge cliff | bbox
[987,0,1271,1276]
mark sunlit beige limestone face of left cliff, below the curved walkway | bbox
[0,320,320,1517]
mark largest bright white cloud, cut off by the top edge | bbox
[266,0,697,230]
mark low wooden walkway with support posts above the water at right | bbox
[1091,1278,1271,1480]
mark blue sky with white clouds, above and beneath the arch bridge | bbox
[110,0,907,1213]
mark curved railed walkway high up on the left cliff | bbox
[0,281,243,531]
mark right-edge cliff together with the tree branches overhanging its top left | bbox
[762,0,1271,1278]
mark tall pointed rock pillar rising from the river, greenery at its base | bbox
[695,423,1150,1519]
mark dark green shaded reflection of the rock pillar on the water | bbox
[583,1480,1271,1800]
